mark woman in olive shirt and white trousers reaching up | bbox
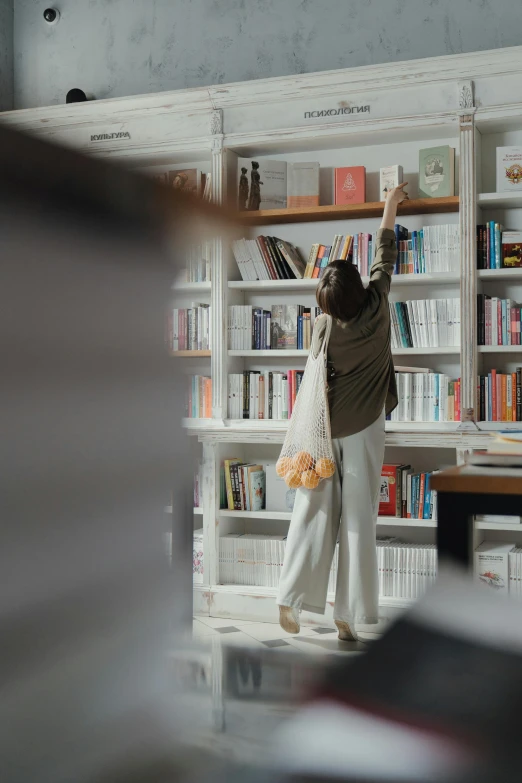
[277,182,408,641]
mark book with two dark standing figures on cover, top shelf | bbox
[238,157,287,212]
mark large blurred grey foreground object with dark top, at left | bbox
[0,127,234,783]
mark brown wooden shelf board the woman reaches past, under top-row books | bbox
[239,196,459,226]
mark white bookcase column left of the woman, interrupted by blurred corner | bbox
[210,109,227,420]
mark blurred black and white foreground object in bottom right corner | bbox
[276,569,522,783]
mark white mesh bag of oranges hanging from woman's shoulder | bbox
[276,315,335,489]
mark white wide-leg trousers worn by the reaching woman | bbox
[277,412,385,624]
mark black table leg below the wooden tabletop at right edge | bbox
[437,492,473,571]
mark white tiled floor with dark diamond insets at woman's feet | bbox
[193,616,379,655]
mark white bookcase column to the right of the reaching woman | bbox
[458,81,477,429]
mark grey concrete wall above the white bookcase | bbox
[14,0,522,108]
